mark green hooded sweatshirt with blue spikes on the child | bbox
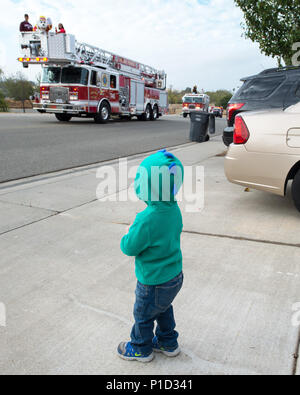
[121,150,184,285]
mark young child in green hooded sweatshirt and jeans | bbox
[118,150,184,362]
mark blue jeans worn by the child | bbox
[131,273,183,355]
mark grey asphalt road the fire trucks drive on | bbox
[0,113,225,182]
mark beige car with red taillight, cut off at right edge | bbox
[225,102,300,211]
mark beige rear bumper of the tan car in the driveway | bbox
[225,144,291,196]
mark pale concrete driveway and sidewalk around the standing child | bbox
[0,137,300,375]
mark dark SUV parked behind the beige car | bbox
[223,66,300,146]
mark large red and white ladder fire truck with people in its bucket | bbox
[18,32,168,123]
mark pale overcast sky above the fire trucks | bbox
[0,0,276,90]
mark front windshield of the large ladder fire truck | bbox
[42,67,89,85]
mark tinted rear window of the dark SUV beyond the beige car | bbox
[234,75,285,100]
